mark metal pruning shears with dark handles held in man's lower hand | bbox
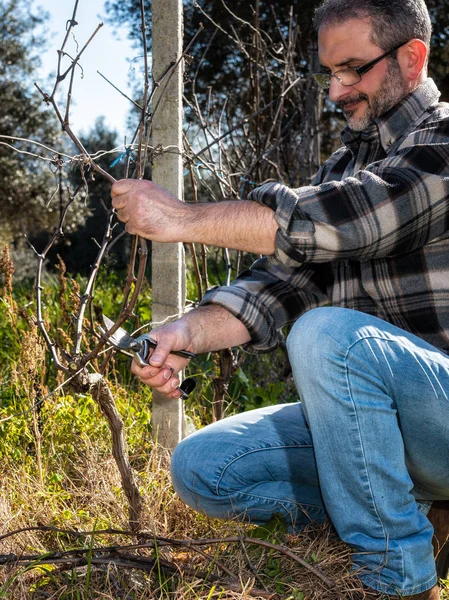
[100,315,196,398]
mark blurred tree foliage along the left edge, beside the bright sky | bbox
[0,0,78,243]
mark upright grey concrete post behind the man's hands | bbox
[152,0,185,449]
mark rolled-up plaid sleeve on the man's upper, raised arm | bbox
[248,134,449,266]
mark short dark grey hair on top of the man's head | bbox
[313,0,432,52]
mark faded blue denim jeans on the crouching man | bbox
[172,308,449,596]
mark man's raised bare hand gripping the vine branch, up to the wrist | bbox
[111,179,191,242]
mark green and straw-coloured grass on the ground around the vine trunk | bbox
[0,254,449,600]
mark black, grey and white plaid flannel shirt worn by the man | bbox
[203,79,449,353]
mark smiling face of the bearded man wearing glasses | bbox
[318,19,408,131]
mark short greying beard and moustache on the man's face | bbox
[337,60,408,131]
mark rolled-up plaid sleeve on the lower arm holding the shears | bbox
[201,258,333,352]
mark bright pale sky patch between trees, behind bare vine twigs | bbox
[34,0,138,143]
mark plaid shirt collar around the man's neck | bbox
[341,77,441,153]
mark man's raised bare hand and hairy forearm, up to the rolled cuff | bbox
[112,179,278,255]
